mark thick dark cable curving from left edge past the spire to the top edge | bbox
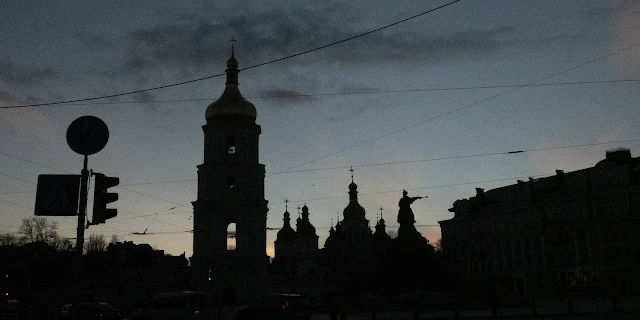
[0,0,462,108]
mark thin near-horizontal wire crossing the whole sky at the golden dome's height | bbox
[0,79,640,109]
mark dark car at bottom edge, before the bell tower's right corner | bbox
[236,294,311,320]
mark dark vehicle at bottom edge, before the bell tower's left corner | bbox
[127,291,213,320]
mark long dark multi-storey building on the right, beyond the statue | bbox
[439,149,640,296]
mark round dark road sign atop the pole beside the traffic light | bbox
[67,116,109,156]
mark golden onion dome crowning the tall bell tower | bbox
[205,52,257,123]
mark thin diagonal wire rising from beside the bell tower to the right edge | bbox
[272,43,640,175]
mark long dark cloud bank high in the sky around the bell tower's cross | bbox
[115,9,513,76]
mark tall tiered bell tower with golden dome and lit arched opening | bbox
[191,50,268,302]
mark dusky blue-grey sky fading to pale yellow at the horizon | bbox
[0,0,640,257]
